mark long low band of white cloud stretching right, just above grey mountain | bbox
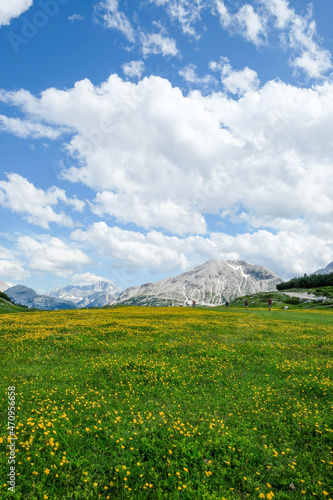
[71,222,333,278]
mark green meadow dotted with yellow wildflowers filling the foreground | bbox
[0,307,333,500]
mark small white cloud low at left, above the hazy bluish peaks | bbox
[17,236,90,277]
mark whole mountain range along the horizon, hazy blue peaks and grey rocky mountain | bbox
[0,260,333,310]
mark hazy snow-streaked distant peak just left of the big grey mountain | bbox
[48,280,120,307]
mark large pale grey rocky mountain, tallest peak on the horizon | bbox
[115,260,283,306]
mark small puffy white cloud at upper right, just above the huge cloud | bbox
[209,57,260,95]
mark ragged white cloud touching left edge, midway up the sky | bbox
[0,173,84,228]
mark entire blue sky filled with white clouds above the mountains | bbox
[0,0,333,291]
